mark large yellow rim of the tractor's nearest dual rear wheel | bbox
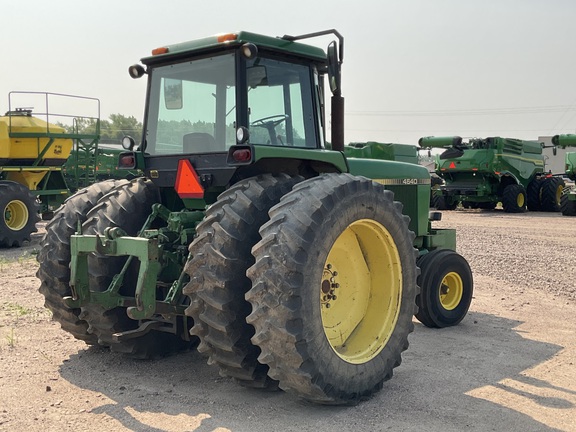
[320,219,402,364]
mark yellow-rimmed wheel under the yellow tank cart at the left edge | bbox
[0,180,40,247]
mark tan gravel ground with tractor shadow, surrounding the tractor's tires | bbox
[0,211,576,432]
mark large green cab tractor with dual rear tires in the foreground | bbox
[38,30,473,404]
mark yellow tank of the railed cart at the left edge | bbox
[0,113,73,165]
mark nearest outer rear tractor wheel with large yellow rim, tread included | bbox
[246,174,418,404]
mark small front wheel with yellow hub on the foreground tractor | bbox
[416,249,474,328]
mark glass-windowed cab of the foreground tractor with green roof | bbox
[120,30,346,207]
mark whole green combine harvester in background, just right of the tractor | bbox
[419,137,564,213]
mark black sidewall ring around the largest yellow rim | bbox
[290,179,417,392]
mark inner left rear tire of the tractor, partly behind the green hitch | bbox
[79,178,195,359]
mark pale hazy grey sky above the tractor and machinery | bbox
[0,0,576,144]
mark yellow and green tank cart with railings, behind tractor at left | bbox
[0,92,137,247]
